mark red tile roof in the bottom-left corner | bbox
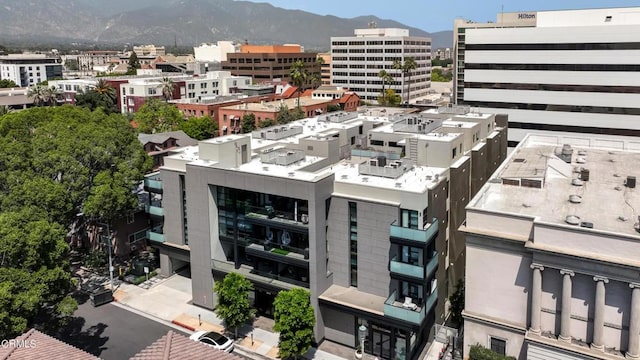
[0,329,99,360]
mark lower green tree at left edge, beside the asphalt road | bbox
[0,208,77,339]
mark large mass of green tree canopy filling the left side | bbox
[0,105,151,339]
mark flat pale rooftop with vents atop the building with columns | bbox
[469,135,640,236]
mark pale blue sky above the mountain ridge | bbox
[244,0,640,32]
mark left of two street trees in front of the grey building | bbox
[213,272,256,338]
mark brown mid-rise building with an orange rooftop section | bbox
[222,44,320,85]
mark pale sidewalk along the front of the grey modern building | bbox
[114,274,344,360]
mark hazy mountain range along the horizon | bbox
[0,0,453,50]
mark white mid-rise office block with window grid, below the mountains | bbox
[331,28,431,103]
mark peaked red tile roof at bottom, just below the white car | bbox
[131,331,242,360]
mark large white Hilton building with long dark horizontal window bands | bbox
[454,8,640,145]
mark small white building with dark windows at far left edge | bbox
[0,54,62,87]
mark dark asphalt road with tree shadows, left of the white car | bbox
[56,294,187,360]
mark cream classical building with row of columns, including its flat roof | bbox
[461,135,640,360]
